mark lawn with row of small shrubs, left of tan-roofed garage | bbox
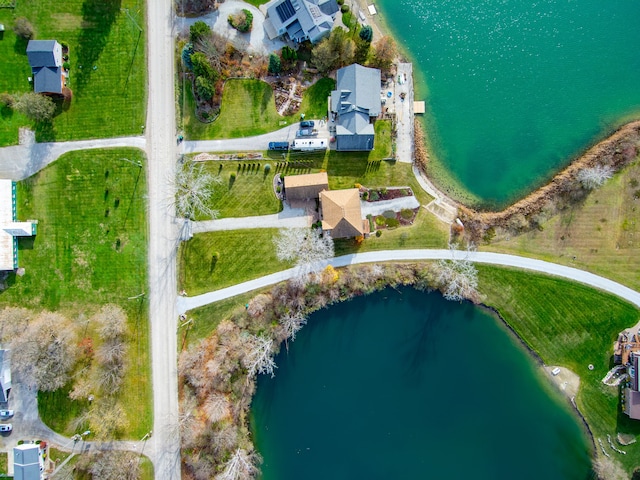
[198,160,282,220]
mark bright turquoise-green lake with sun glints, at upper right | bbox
[376,0,640,205]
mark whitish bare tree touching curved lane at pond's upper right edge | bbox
[435,245,478,301]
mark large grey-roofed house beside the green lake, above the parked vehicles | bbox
[330,63,382,152]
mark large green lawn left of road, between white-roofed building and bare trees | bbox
[0,149,152,438]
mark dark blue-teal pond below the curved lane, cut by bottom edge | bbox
[252,289,591,480]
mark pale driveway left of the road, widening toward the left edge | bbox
[0,137,146,181]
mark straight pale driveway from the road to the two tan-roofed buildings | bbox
[191,203,313,234]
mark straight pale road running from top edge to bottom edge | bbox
[147,0,180,480]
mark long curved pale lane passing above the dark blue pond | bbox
[178,250,640,313]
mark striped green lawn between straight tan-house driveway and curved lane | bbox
[178,228,292,296]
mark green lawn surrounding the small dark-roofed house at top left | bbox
[0,0,146,146]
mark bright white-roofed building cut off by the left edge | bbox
[0,179,38,272]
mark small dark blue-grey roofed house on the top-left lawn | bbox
[27,40,65,94]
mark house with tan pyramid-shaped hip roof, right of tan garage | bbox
[320,188,370,238]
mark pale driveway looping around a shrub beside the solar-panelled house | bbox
[176,0,285,55]
